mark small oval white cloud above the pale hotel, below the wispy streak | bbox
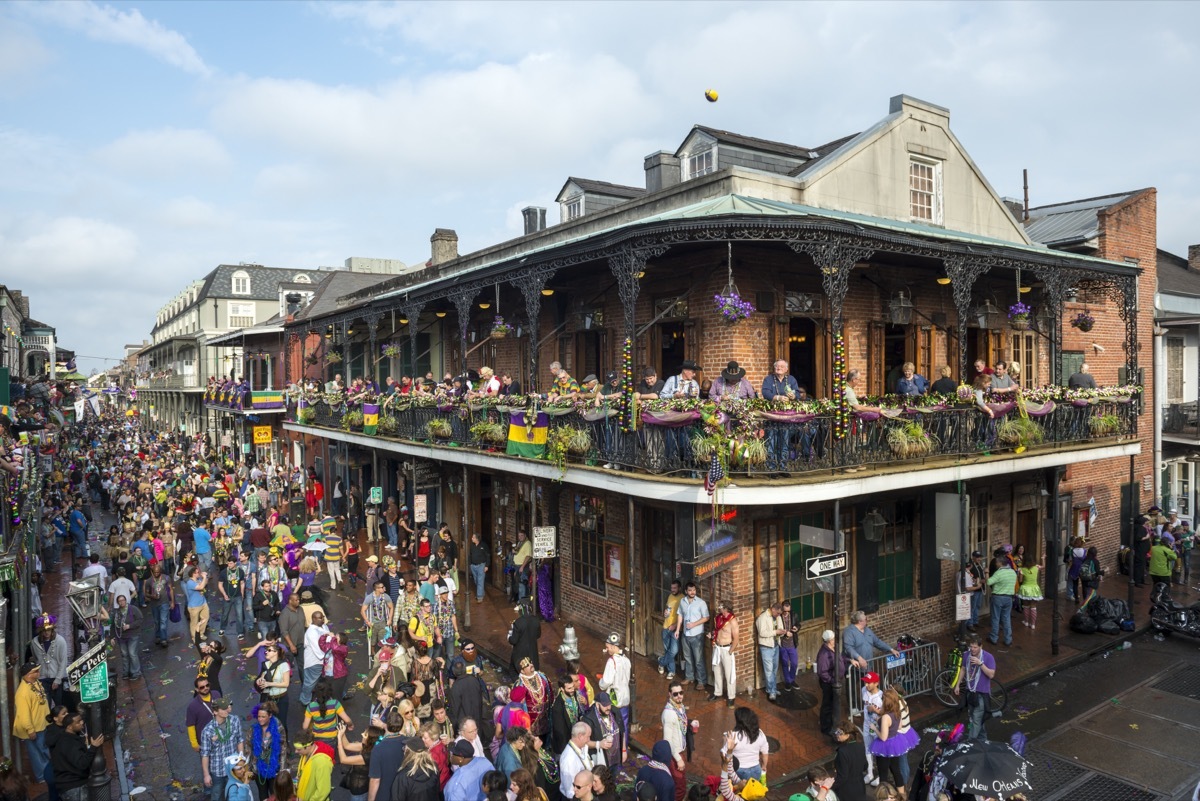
[98,128,232,180]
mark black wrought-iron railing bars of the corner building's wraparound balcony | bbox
[295,401,1136,477]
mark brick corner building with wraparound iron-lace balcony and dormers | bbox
[276,96,1154,691]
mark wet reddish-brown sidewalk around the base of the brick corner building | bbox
[468,576,1200,785]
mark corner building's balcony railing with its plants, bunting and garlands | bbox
[288,396,1138,477]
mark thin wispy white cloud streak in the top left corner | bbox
[22,0,212,76]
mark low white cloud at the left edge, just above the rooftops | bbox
[0,217,138,281]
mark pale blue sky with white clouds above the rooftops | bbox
[0,0,1200,373]
